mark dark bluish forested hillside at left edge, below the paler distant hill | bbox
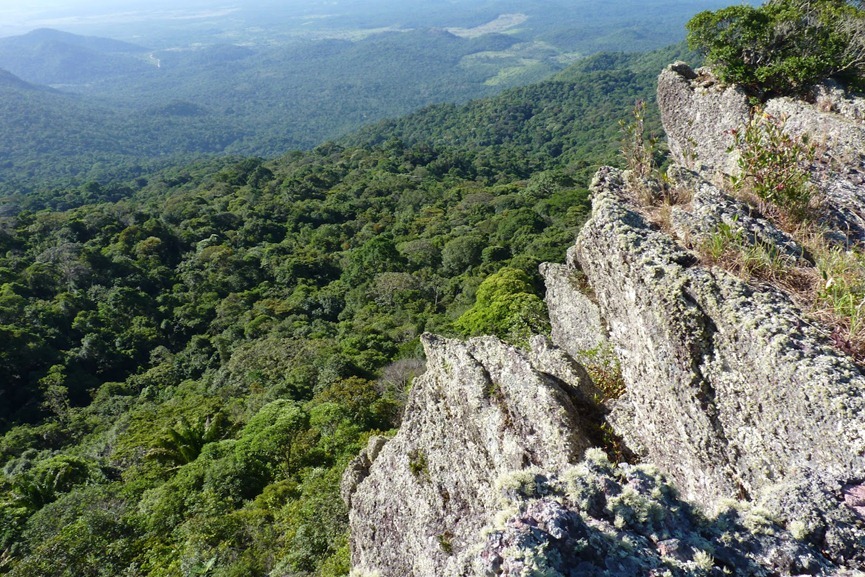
[0,70,248,196]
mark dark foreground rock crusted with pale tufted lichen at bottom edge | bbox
[464,450,837,577]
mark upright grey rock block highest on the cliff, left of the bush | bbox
[658,62,750,174]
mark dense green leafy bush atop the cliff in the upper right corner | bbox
[687,0,865,97]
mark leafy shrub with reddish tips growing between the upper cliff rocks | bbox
[732,109,815,221]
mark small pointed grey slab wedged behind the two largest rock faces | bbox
[540,263,607,357]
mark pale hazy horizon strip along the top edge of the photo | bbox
[0,0,753,44]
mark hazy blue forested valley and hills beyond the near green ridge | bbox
[0,0,723,195]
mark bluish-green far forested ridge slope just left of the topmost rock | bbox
[339,44,696,177]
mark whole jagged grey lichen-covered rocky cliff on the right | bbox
[343,63,865,577]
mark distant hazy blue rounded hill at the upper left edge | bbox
[0,29,149,85]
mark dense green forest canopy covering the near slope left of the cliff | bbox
[0,46,674,577]
